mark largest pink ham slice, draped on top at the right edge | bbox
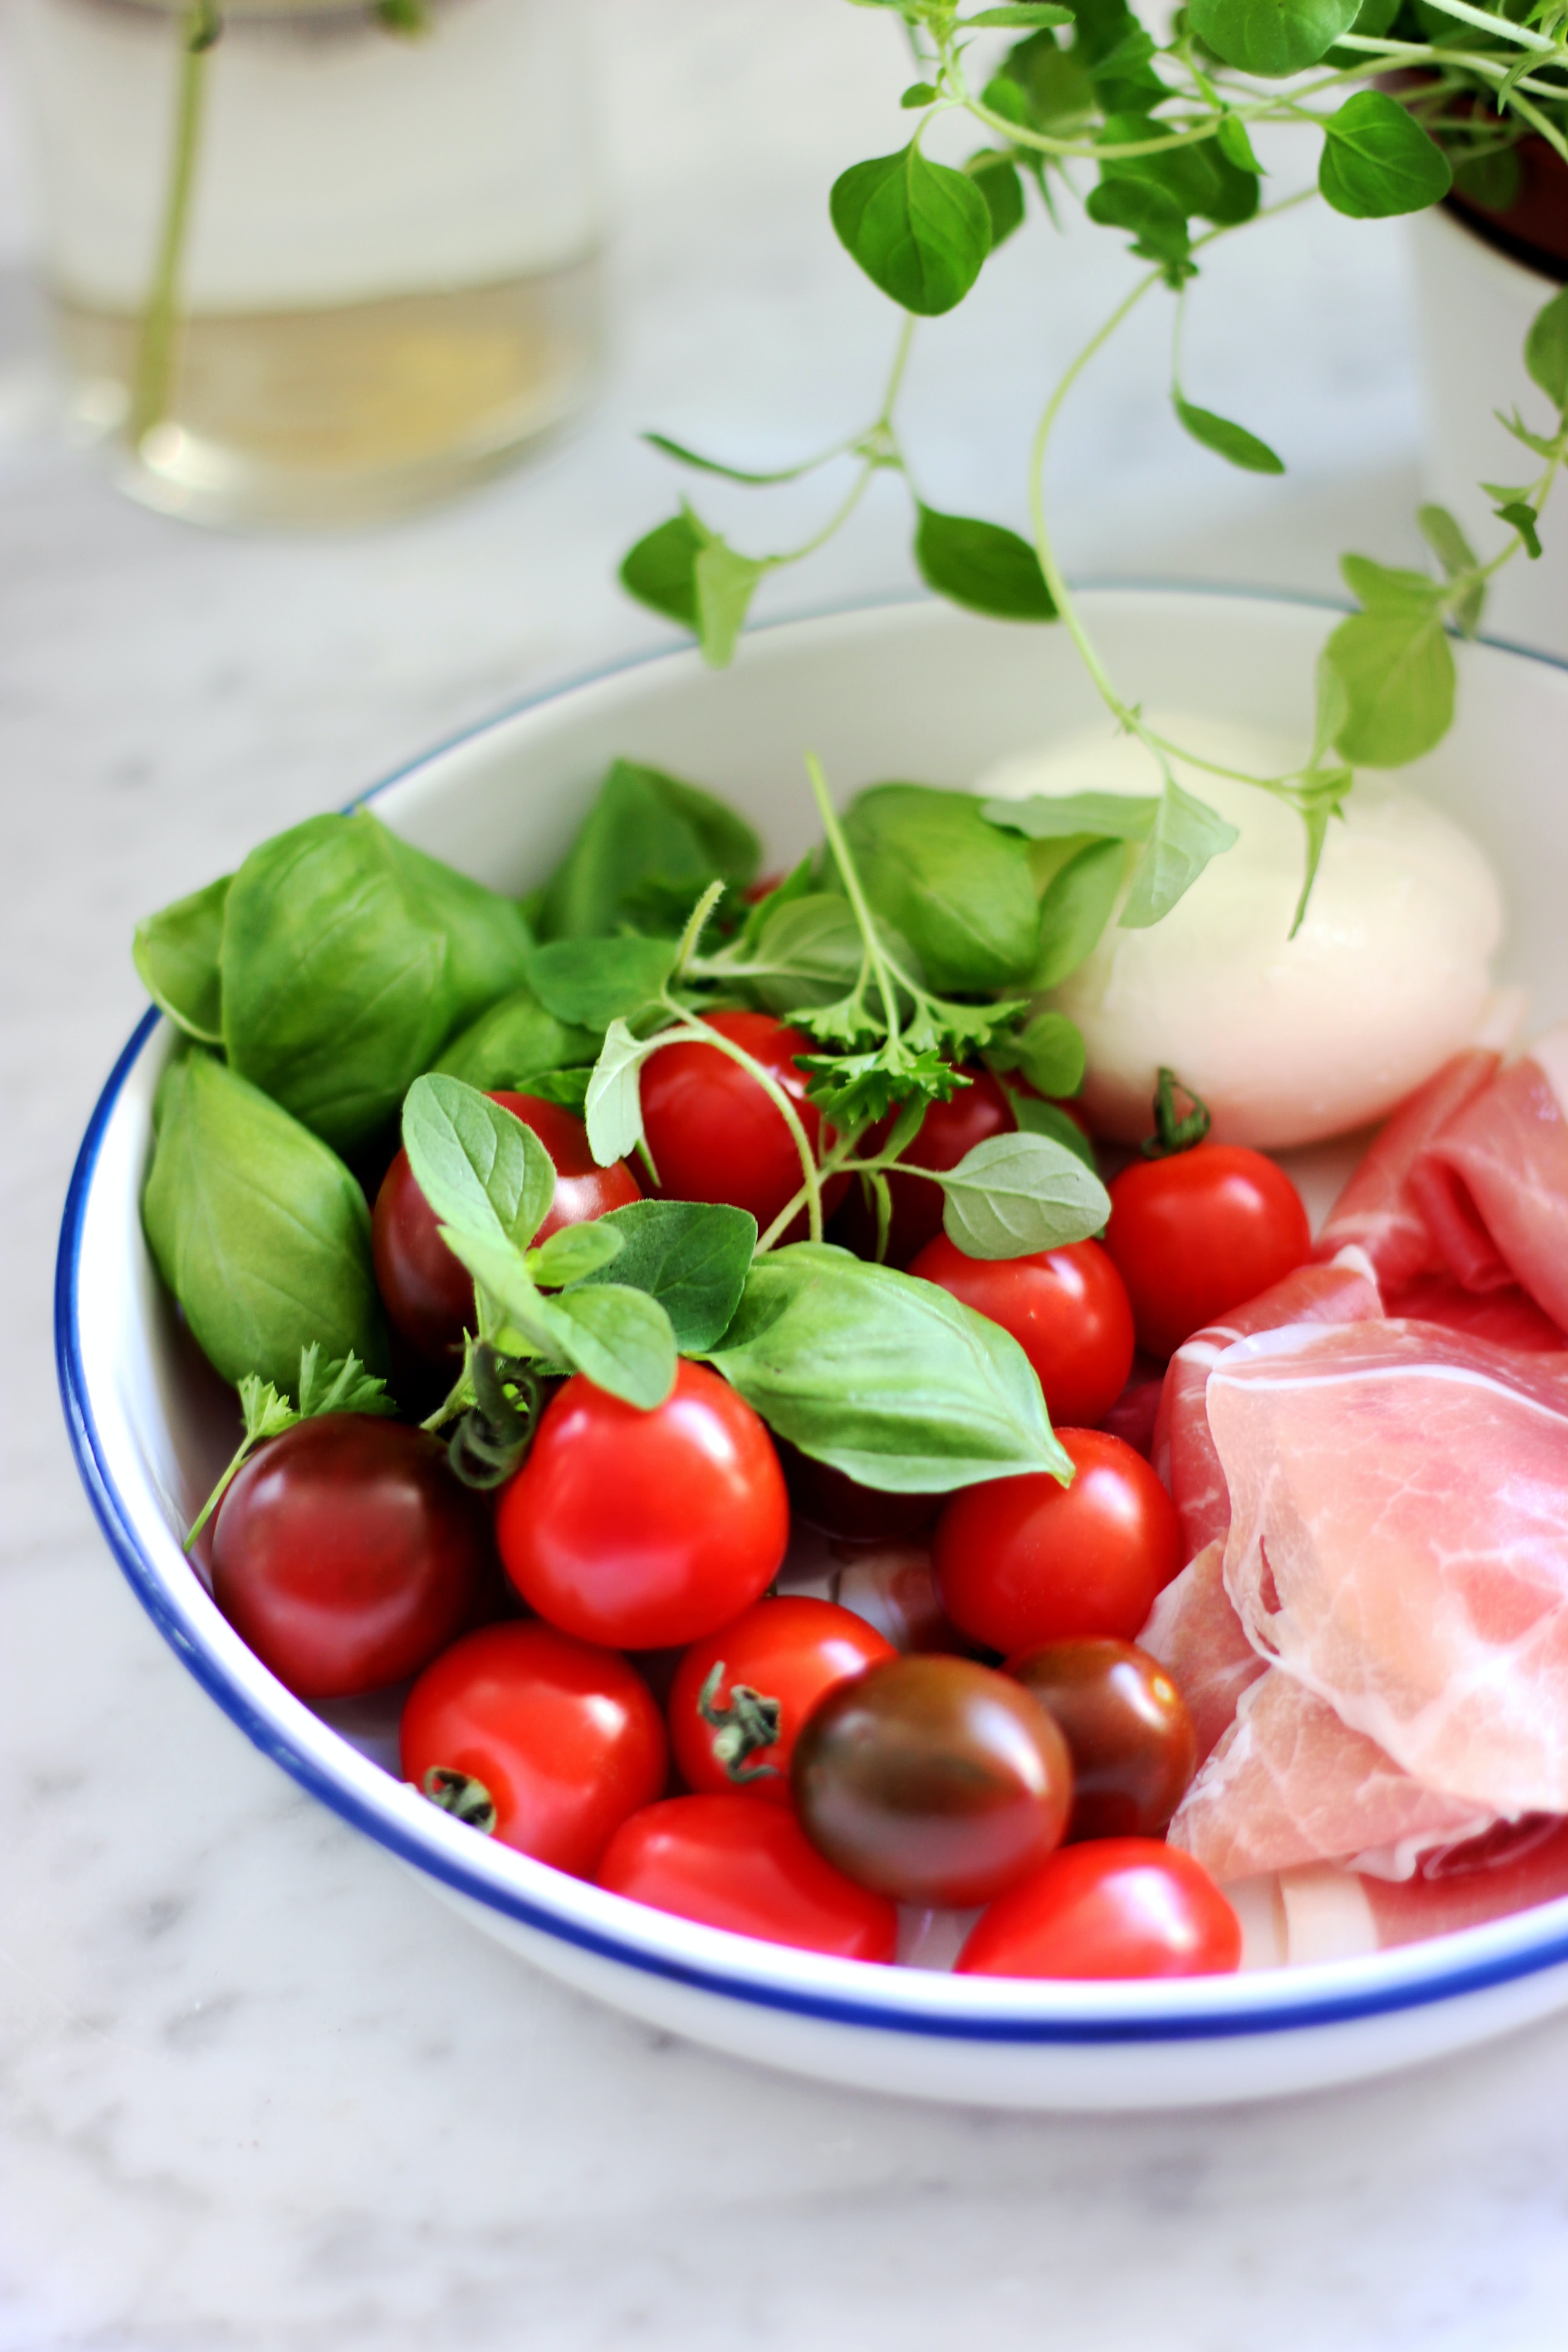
[1208,1322,1568,1816]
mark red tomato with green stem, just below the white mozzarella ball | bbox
[1105,1143,1312,1355]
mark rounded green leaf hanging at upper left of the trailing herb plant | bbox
[828,141,992,318]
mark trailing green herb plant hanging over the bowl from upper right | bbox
[621,0,1568,926]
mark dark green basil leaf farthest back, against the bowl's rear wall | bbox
[539,760,762,938]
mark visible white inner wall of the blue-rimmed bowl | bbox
[59,588,1568,2060]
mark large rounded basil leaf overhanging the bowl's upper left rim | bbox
[223,809,531,1150]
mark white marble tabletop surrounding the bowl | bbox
[0,0,1568,2352]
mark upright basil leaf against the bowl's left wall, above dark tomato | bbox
[141,1049,388,1392]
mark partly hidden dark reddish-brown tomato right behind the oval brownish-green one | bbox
[1006,1639,1196,1839]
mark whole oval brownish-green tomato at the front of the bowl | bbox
[790,1658,1072,1905]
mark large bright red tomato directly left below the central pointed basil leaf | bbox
[496,1362,790,1649]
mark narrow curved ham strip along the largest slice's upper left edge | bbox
[1150,1249,1382,1571]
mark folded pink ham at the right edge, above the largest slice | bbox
[1408,1021,1568,1327]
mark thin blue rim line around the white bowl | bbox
[54,578,1568,2044]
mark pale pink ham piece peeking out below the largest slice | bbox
[1168,1665,1495,1882]
